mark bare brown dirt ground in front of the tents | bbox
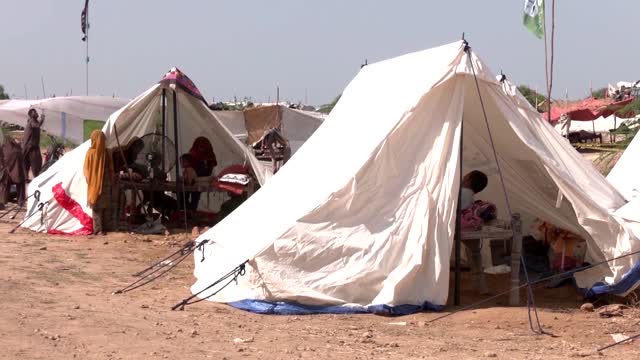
[0,214,640,359]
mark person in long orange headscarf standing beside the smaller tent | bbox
[84,130,115,235]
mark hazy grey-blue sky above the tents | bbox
[0,0,640,104]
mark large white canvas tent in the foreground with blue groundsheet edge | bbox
[191,42,640,313]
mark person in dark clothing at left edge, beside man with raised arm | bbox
[0,135,26,206]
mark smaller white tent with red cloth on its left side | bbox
[23,69,264,234]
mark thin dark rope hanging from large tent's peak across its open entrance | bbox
[460,40,544,335]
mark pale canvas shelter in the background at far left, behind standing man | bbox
[0,96,129,145]
